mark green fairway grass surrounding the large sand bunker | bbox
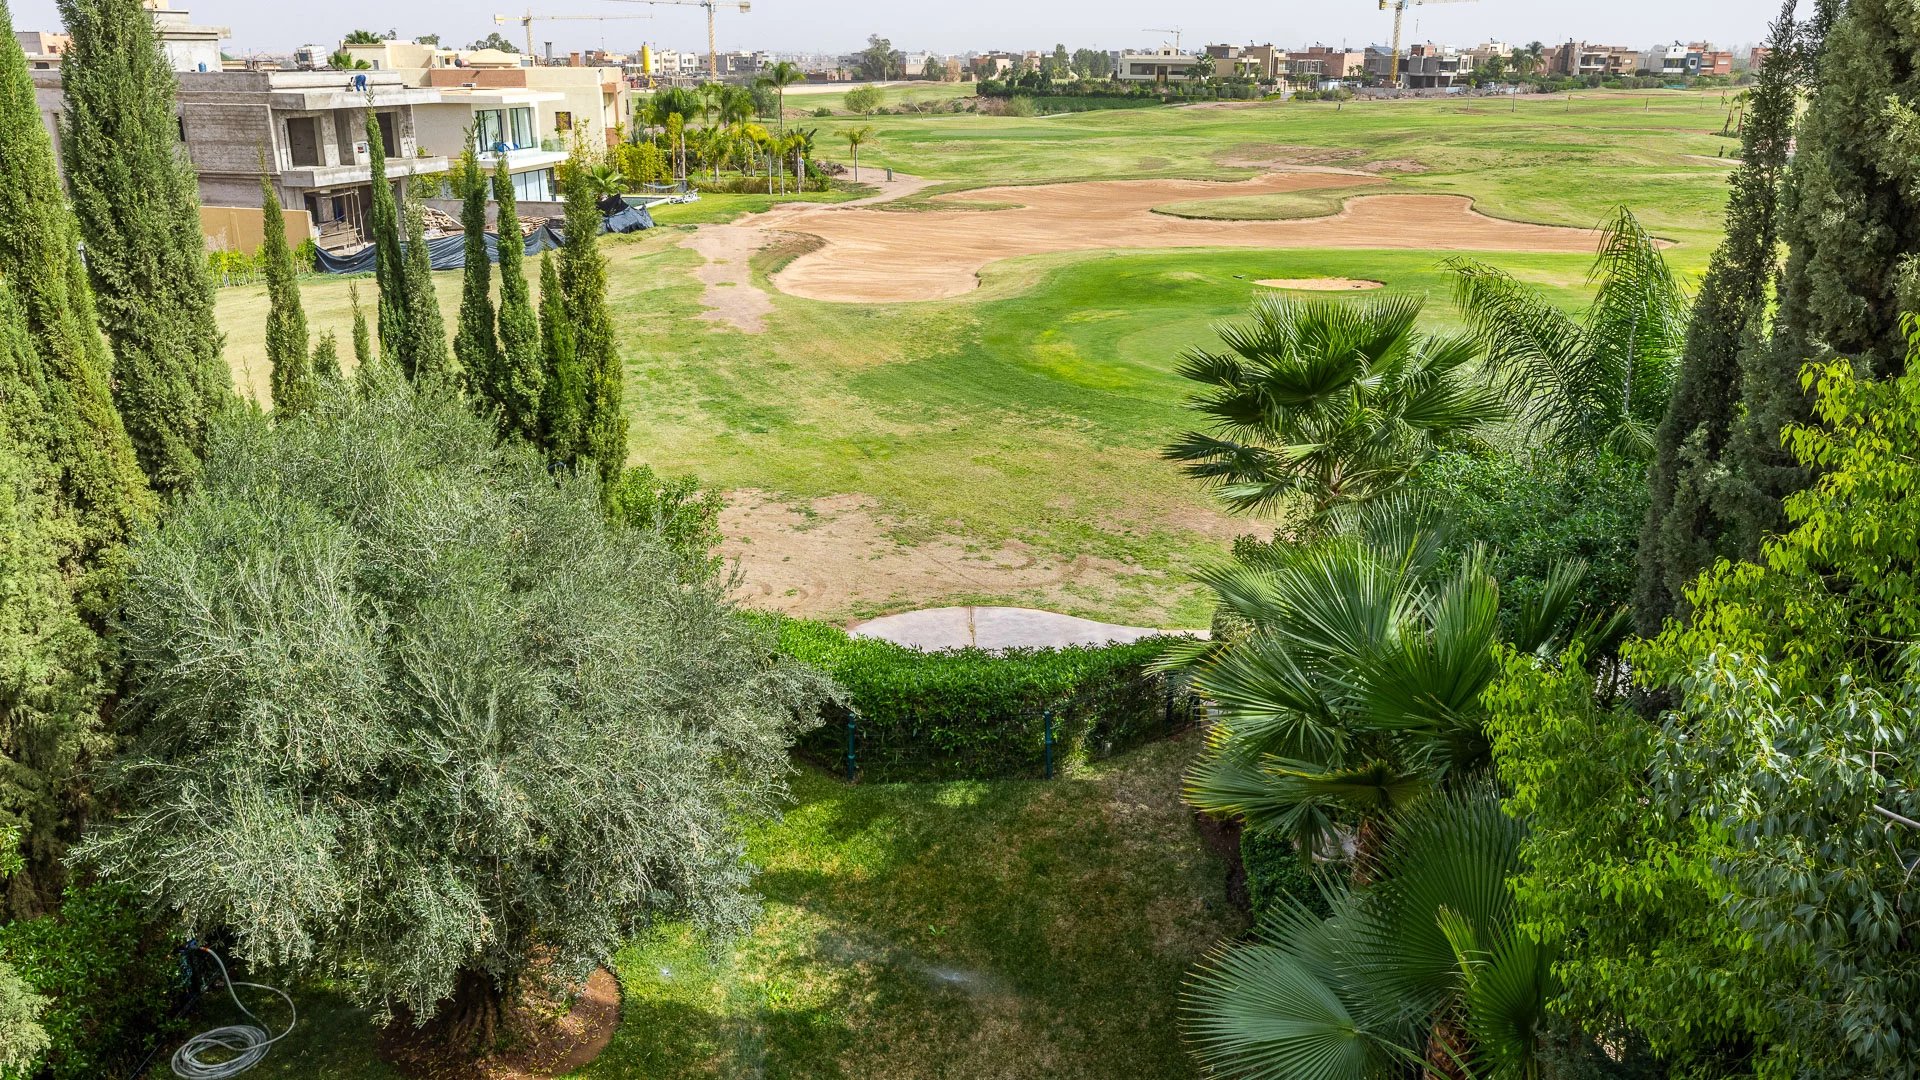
[221,86,1726,626]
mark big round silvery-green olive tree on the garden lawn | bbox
[83,365,824,1047]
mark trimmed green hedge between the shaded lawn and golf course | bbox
[770,619,1192,780]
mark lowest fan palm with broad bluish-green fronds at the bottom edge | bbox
[1185,784,1555,1080]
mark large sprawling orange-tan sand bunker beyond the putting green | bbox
[753,171,1599,304]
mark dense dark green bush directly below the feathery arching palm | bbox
[1413,452,1647,630]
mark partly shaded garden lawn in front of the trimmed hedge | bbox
[191,736,1244,1080]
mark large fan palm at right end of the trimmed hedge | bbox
[1164,496,1613,872]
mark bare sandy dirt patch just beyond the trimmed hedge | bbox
[720,490,1173,619]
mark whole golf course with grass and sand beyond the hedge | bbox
[219,88,1738,628]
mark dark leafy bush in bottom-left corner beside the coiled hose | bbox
[0,884,175,1080]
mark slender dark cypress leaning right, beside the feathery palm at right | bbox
[1634,0,1801,636]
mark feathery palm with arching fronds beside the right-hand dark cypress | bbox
[1448,208,1688,457]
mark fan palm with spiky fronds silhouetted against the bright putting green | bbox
[1165,296,1507,513]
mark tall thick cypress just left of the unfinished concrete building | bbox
[60,0,234,492]
